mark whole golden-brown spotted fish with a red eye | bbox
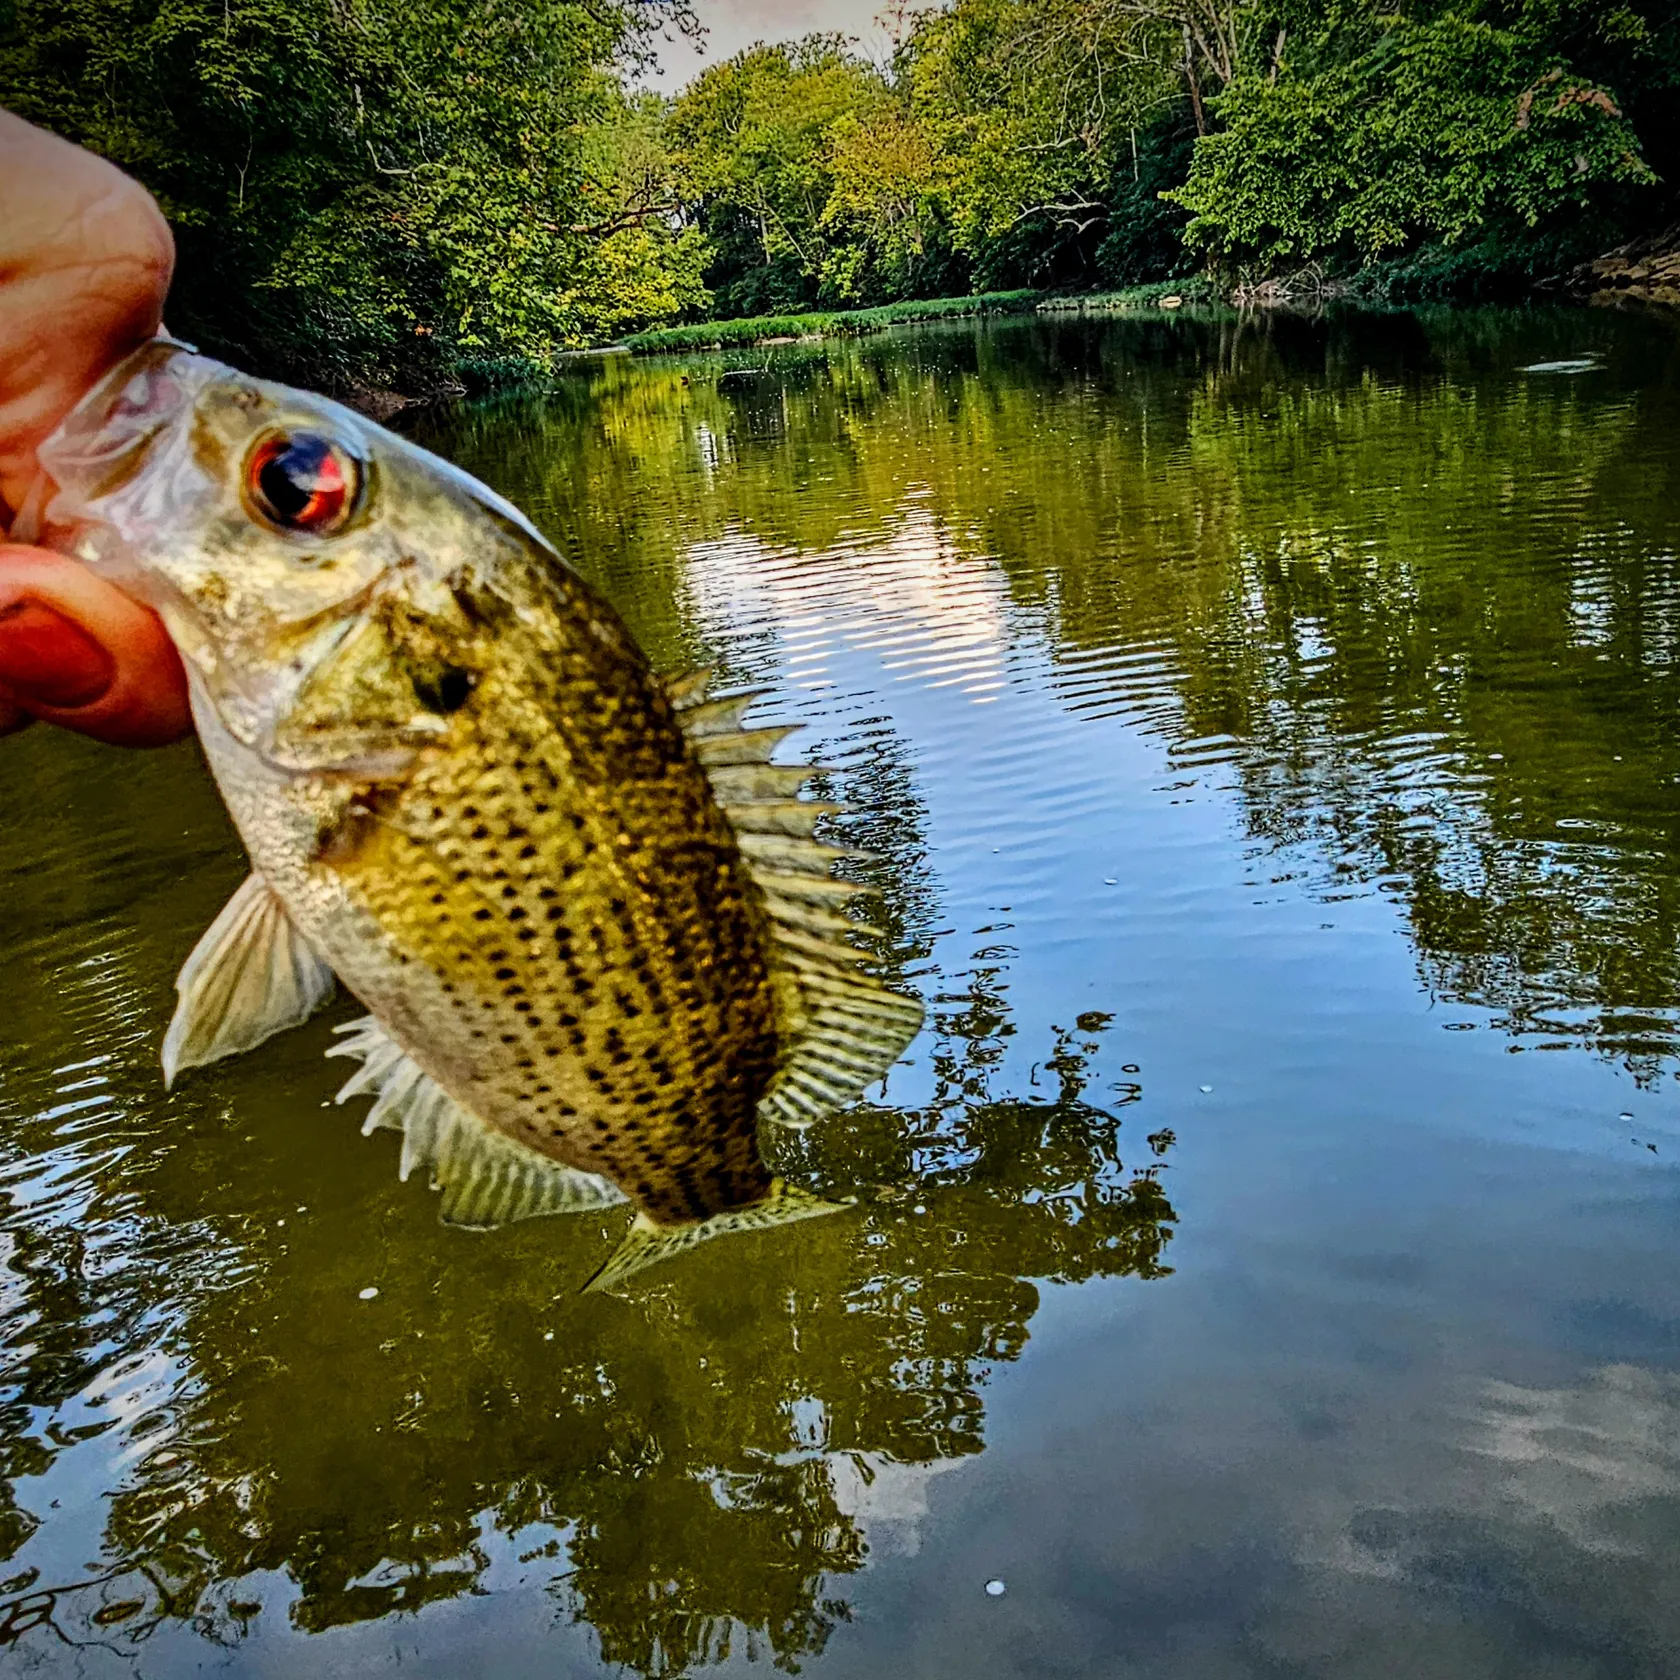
[40,339,922,1289]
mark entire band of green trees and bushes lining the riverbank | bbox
[0,0,1680,399]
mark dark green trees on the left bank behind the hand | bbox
[0,0,702,386]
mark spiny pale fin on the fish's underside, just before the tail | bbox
[328,1015,625,1231]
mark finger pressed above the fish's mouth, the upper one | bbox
[0,111,175,526]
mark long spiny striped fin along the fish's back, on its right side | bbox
[667,672,922,1127]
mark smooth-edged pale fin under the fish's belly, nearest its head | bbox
[163,874,334,1087]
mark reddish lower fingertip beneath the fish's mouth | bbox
[0,544,192,746]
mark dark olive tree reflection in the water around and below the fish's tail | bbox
[0,692,1174,1675]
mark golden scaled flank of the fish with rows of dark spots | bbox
[327,630,778,1220]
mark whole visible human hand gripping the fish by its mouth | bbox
[0,111,192,746]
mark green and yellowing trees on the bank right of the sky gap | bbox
[674,0,1680,314]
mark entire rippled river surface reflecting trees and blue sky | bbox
[0,311,1680,1680]
